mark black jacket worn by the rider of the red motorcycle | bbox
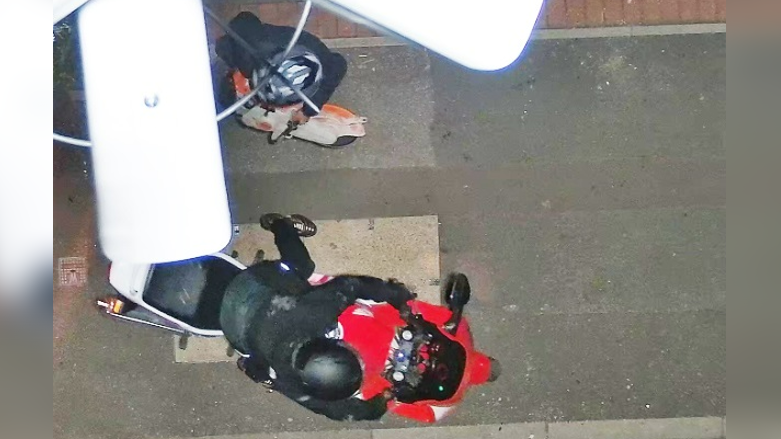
[236,262,414,420]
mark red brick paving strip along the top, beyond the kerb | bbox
[210,0,727,38]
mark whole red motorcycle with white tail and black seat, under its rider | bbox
[97,253,500,422]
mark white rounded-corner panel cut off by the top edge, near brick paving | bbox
[316,0,542,70]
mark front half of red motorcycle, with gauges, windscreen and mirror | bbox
[330,273,501,422]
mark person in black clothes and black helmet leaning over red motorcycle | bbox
[220,214,415,420]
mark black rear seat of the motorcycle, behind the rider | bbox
[143,256,241,330]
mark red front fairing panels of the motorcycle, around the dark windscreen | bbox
[333,301,491,422]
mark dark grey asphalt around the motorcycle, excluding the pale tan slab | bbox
[54,35,726,438]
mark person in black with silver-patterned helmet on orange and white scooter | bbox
[215,11,347,123]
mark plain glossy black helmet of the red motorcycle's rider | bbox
[293,338,363,401]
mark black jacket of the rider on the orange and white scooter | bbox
[215,11,347,116]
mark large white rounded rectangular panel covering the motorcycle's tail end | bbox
[78,0,232,263]
